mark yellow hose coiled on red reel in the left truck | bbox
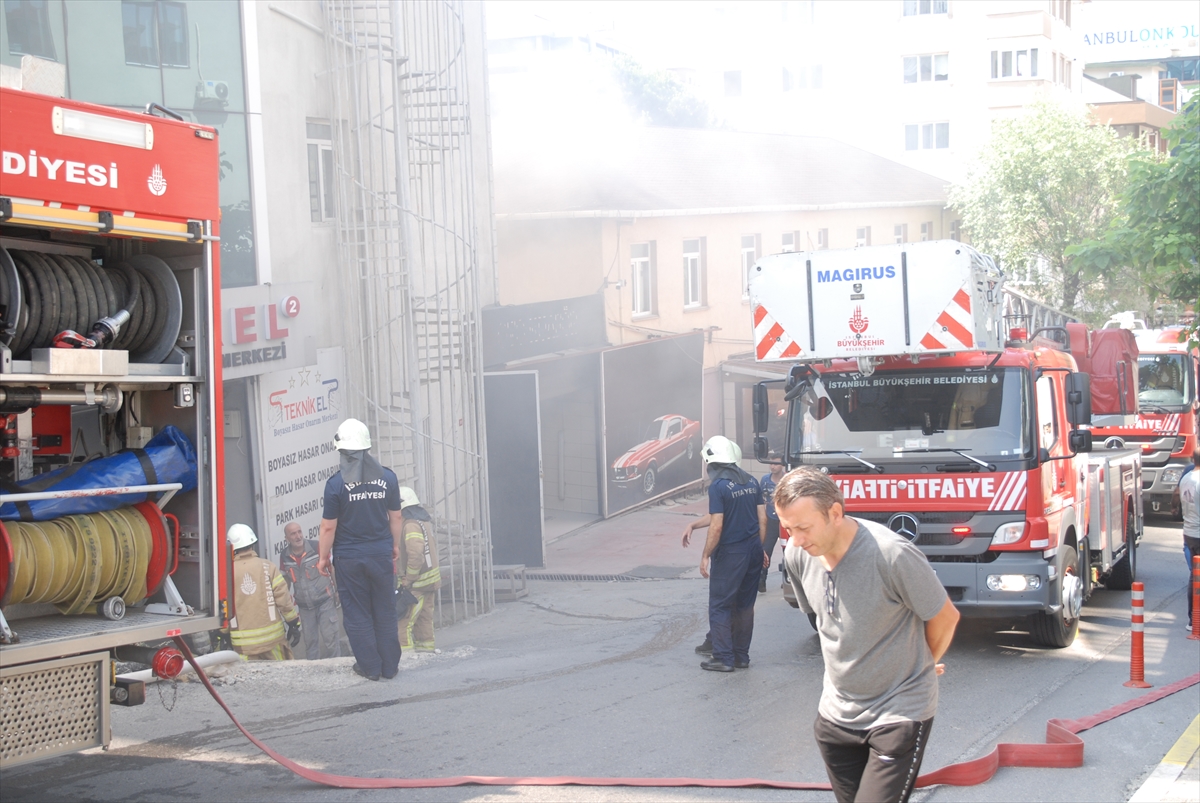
[0,502,178,619]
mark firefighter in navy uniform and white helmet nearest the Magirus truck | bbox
[683,435,770,672]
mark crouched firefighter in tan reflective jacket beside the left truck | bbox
[226,525,300,661]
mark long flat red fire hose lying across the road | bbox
[175,637,1200,791]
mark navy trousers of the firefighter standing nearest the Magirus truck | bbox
[708,542,762,666]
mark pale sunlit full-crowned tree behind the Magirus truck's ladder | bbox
[950,100,1134,314]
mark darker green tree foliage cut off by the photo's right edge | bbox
[1069,100,1200,331]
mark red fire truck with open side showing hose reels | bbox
[0,89,228,767]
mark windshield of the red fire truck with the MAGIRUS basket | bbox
[791,368,1031,462]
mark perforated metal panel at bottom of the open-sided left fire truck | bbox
[0,653,108,768]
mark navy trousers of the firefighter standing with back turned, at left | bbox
[334,553,400,677]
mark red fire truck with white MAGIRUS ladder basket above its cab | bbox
[750,241,1142,647]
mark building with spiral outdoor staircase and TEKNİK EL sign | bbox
[0,0,494,618]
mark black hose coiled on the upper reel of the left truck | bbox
[0,246,182,362]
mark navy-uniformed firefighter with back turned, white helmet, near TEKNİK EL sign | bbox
[317,418,403,681]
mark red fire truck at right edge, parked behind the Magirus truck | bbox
[1092,312,1200,517]
